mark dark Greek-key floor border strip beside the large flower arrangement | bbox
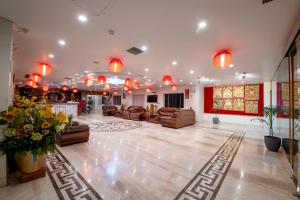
[46,150,103,200]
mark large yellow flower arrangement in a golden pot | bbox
[0,96,67,173]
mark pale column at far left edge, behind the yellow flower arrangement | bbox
[0,17,13,187]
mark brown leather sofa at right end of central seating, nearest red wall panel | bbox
[160,109,196,128]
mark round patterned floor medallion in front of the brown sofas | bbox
[89,120,142,132]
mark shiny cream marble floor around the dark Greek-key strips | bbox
[0,114,297,200]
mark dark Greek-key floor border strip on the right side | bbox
[174,131,244,200]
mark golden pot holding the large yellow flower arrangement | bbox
[15,151,46,173]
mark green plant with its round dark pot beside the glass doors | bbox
[251,106,281,152]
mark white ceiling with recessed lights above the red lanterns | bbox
[0,0,300,88]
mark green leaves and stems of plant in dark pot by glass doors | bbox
[251,106,278,136]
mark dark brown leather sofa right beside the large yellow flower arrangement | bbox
[56,122,90,146]
